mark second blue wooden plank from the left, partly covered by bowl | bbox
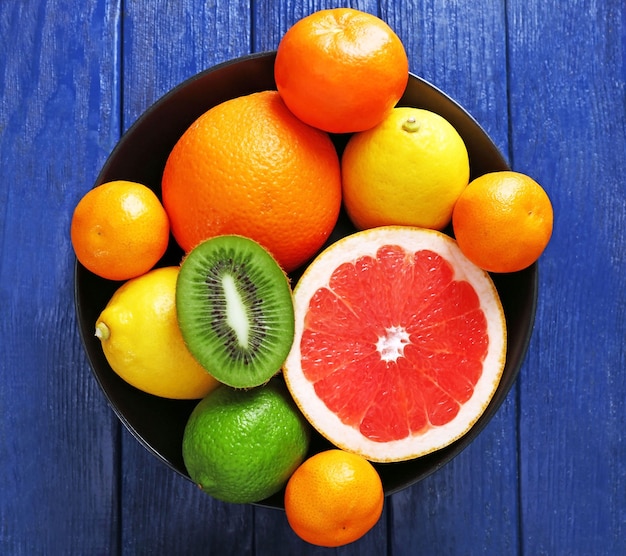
[120,0,253,555]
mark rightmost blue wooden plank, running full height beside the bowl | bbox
[508,0,626,555]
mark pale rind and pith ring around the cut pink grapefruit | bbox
[283,226,507,463]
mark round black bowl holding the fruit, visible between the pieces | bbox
[75,53,537,508]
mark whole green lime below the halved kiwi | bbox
[183,378,310,503]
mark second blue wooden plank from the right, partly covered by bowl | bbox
[383,0,526,554]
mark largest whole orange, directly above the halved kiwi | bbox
[162,91,341,272]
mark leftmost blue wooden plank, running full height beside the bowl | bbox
[0,0,119,554]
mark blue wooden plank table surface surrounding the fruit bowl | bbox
[0,0,626,556]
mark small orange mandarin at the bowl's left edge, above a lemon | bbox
[71,180,170,280]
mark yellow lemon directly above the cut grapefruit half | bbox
[341,107,470,230]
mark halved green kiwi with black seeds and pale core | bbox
[176,235,294,388]
